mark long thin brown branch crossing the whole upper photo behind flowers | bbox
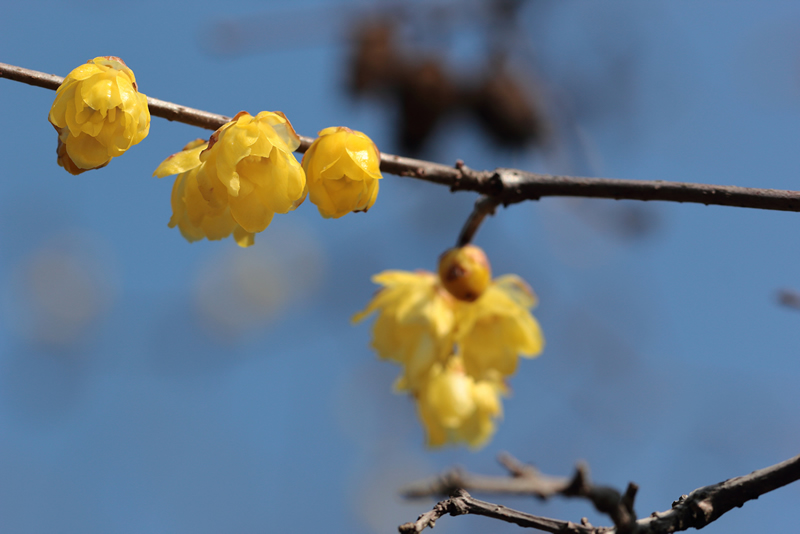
[0,63,800,211]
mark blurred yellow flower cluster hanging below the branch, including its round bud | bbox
[353,249,544,448]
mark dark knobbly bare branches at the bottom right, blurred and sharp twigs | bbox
[399,456,800,534]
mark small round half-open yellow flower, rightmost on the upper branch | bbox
[303,126,381,219]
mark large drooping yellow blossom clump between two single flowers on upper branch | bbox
[153,111,306,247]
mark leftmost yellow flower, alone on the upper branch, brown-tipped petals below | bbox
[48,56,150,174]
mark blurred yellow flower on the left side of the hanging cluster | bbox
[353,271,454,391]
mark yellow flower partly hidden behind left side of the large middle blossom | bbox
[153,139,253,247]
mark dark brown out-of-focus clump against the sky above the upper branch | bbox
[349,17,546,154]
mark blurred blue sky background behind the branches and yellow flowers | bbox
[0,0,800,534]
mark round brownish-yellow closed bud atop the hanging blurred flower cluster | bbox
[439,245,492,302]
